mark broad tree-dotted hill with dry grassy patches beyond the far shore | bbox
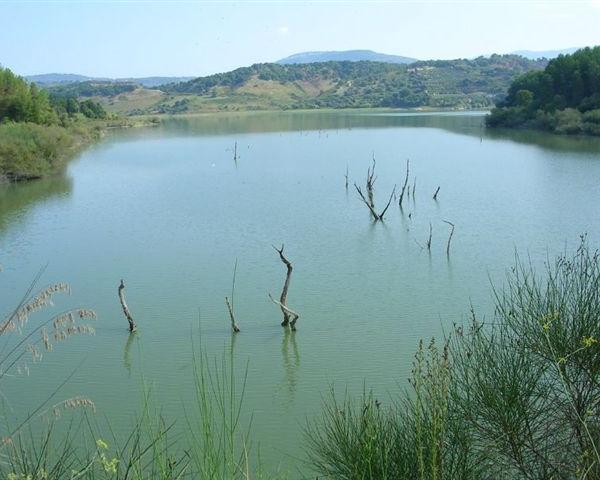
[155,55,547,113]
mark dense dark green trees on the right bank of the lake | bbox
[487,47,600,135]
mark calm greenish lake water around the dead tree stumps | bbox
[0,112,600,471]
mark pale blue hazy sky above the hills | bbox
[0,0,600,77]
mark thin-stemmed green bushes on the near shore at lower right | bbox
[306,239,600,480]
